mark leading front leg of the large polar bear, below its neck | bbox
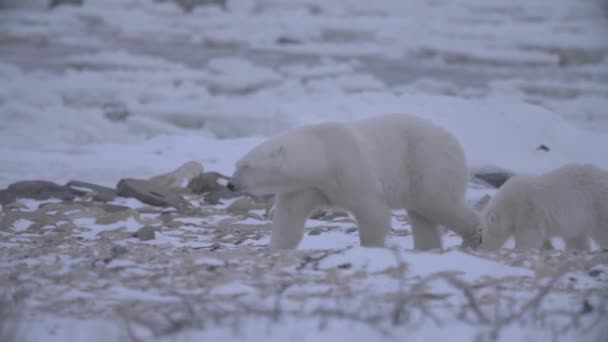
[270,189,327,250]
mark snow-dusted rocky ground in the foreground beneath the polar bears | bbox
[0,163,608,341]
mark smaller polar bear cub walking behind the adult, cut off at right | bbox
[480,164,608,250]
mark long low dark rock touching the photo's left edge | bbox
[0,180,80,204]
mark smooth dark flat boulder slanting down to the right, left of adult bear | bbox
[116,178,191,210]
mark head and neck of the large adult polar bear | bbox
[228,130,326,195]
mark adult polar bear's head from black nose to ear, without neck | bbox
[226,143,287,195]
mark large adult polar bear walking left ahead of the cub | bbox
[227,114,480,250]
